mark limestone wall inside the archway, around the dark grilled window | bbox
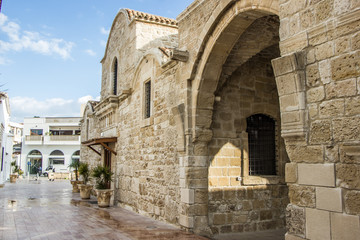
[208,46,288,234]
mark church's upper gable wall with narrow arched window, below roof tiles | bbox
[101,10,178,99]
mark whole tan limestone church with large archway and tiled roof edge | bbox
[81,0,360,240]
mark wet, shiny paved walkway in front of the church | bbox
[0,178,284,240]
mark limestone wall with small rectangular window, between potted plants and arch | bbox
[116,56,180,223]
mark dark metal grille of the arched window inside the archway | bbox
[246,114,276,175]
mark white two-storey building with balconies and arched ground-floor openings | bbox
[21,117,81,174]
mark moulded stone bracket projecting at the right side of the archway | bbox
[272,51,308,139]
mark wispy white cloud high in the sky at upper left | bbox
[0,13,74,64]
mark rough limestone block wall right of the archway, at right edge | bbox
[274,0,360,239]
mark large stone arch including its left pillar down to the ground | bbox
[180,1,296,235]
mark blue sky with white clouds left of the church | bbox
[0,0,193,123]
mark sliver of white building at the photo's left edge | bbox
[0,92,13,184]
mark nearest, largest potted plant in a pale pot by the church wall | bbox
[92,165,114,207]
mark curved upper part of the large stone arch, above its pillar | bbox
[191,0,279,140]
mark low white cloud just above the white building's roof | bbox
[10,95,100,122]
